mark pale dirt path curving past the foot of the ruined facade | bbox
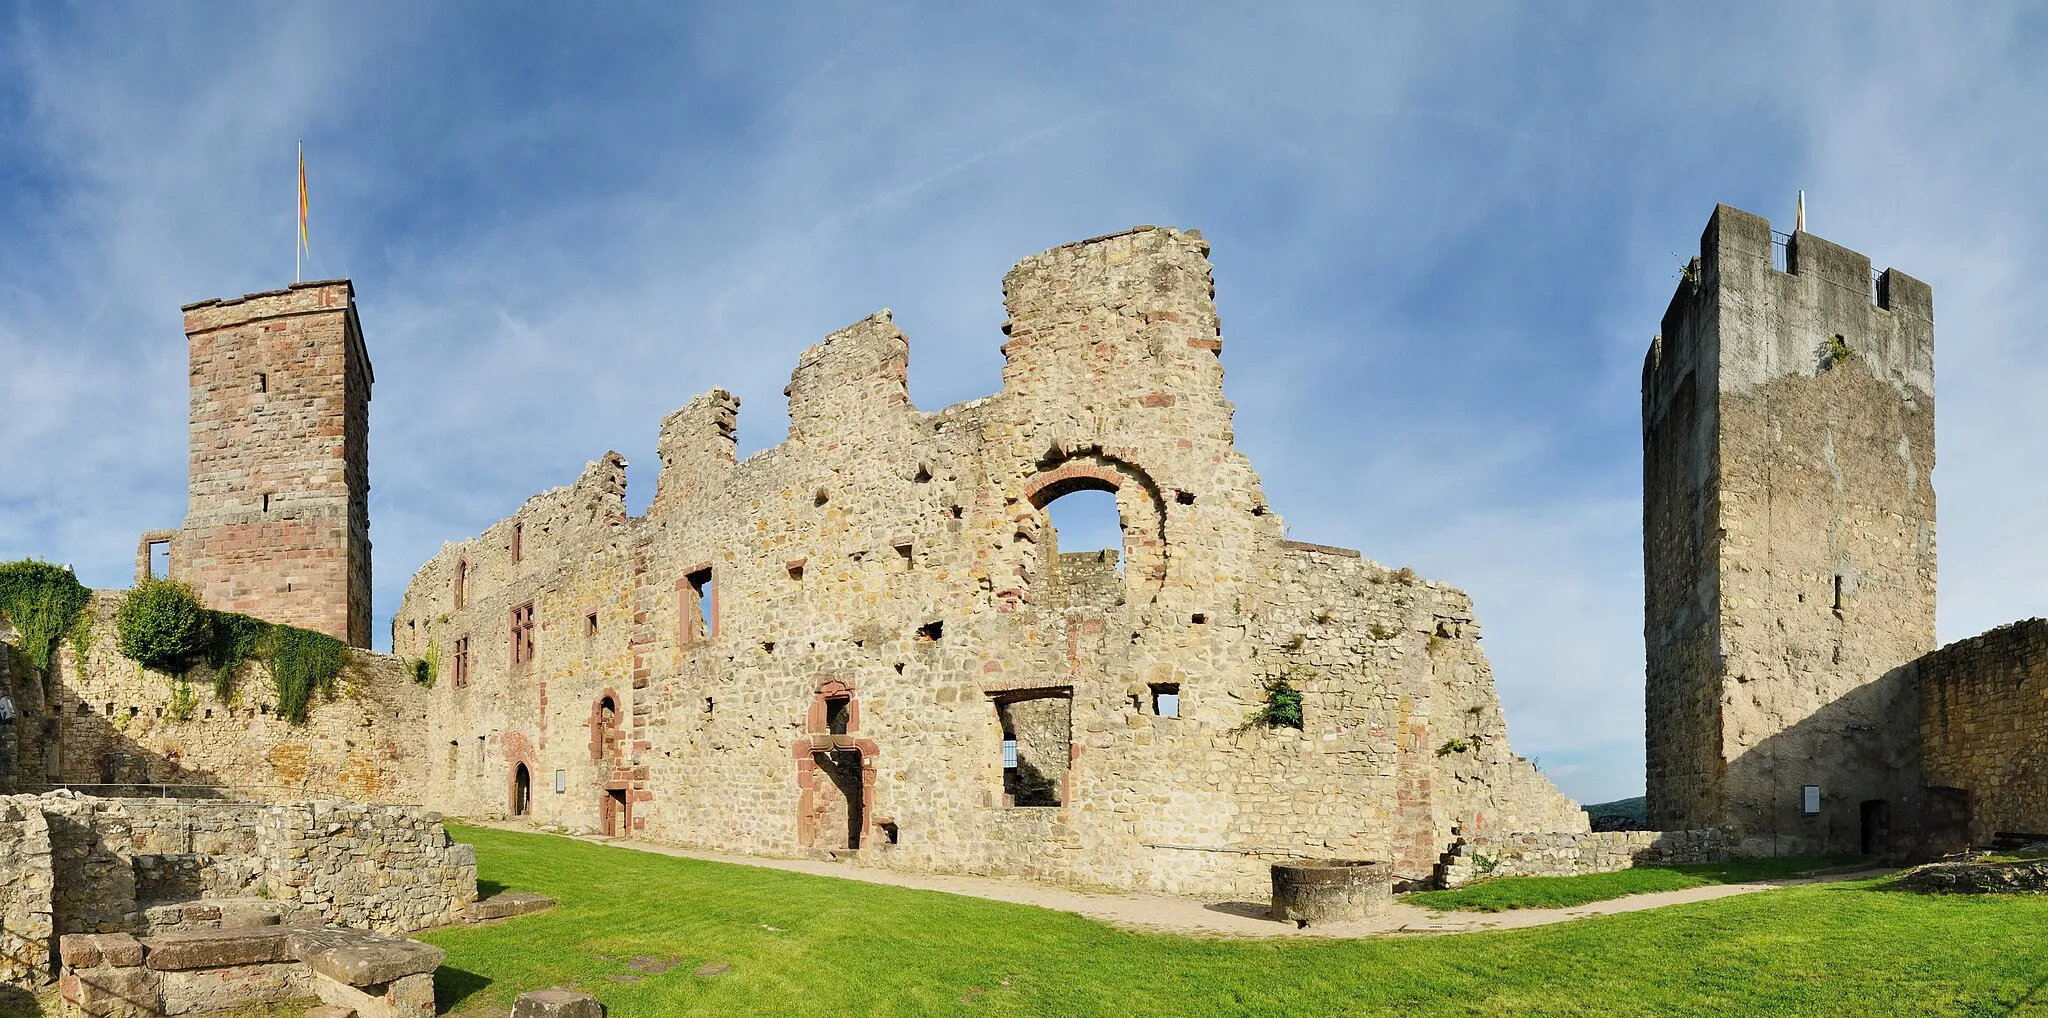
[481,823,1870,938]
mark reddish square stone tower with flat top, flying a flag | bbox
[165,279,375,647]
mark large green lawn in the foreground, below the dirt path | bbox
[424,830,2048,1018]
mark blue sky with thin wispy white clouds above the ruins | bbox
[0,2,2048,801]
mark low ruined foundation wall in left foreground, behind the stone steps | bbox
[0,793,477,983]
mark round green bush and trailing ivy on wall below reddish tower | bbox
[115,580,348,725]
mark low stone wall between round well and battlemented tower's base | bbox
[1438,830,1729,887]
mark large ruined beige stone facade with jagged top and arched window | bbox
[393,227,1587,893]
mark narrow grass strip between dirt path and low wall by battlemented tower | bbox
[1403,856,1860,911]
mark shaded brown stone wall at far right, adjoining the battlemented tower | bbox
[1913,619,2048,848]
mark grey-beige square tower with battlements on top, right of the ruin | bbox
[1642,205,1935,854]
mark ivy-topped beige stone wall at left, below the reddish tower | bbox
[0,590,428,803]
